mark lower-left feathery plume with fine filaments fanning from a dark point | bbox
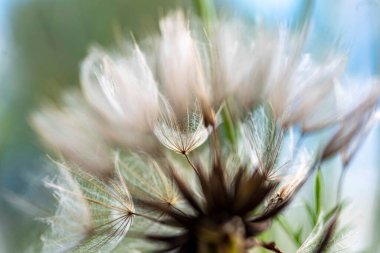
[42,163,134,252]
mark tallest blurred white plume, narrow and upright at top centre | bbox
[157,12,206,114]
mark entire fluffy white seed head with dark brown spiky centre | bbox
[32,11,380,253]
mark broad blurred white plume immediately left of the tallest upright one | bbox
[81,45,159,147]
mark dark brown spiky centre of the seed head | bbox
[138,145,318,253]
